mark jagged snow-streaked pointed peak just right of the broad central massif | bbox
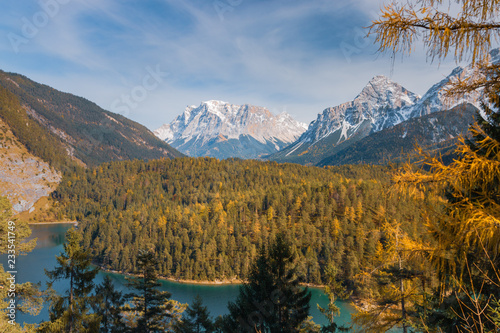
[269,76,419,164]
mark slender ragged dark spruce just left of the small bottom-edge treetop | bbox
[126,250,173,333]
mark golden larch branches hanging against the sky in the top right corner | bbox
[369,0,500,97]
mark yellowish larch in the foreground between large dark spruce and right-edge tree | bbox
[352,222,426,333]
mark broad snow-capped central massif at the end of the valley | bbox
[154,100,306,159]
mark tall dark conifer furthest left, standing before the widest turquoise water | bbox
[39,228,100,333]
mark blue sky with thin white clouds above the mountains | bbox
[0,0,468,129]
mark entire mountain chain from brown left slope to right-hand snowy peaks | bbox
[0,49,500,211]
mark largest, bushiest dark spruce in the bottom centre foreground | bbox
[225,233,311,333]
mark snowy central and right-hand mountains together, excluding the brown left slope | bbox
[154,49,500,165]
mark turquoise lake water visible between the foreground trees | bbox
[6,224,353,324]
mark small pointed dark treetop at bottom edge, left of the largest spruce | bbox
[175,295,214,333]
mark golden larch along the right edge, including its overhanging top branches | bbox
[360,0,500,332]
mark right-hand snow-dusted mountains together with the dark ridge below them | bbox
[266,50,494,166]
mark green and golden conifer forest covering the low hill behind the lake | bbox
[54,158,430,291]
